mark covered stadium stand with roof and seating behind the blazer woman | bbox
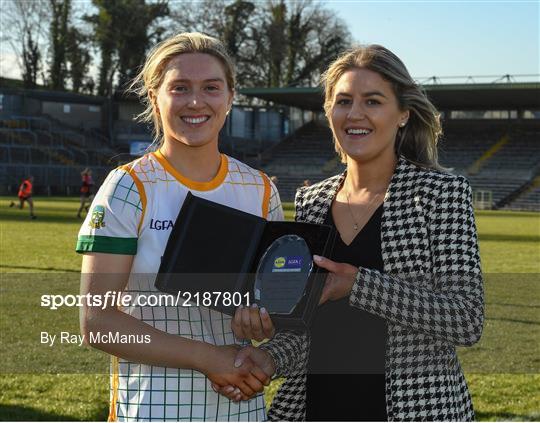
[240,82,540,210]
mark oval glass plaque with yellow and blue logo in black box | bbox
[254,235,313,315]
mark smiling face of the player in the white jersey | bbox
[150,53,233,147]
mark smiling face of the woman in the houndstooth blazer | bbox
[328,68,409,162]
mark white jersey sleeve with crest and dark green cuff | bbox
[76,168,144,255]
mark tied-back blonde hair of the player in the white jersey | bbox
[128,32,236,147]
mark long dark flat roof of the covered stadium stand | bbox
[240,82,540,111]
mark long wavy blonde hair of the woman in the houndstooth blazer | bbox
[321,44,443,170]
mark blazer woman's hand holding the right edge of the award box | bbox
[313,255,358,305]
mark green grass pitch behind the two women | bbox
[0,197,540,421]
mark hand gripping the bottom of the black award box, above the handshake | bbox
[231,303,276,342]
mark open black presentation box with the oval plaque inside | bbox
[155,192,336,331]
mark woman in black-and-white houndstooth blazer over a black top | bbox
[224,45,483,421]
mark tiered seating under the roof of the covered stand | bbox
[262,121,540,210]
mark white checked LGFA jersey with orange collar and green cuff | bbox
[77,151,283,421]
